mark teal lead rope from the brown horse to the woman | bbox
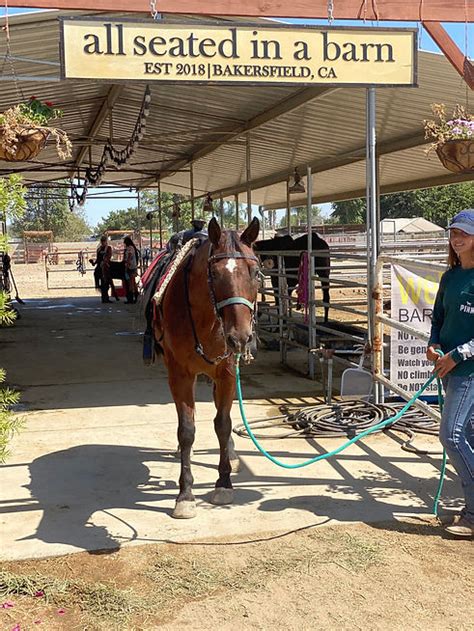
[235,352,446,517]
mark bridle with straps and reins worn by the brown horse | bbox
[184,243,259,365]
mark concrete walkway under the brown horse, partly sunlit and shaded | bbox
[0,297,460,559]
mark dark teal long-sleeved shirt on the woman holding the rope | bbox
[429,267,474,377]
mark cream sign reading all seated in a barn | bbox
[61,18,417,86]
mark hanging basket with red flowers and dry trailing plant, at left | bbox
[0,96,72,162]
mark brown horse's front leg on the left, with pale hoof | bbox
[168,365,196,519]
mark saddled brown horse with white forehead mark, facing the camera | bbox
[154,218,260,519]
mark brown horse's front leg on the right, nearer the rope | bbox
[211,360,238,505]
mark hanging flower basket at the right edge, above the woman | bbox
[423,103,474,173]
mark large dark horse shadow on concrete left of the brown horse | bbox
[19,445,181,551]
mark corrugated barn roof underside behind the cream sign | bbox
[0,11,472,208]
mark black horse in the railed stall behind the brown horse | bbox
[254,232,331,322]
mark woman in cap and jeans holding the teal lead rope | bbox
[426,209,474,537]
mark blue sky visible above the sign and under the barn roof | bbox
[0,9,474,225]
